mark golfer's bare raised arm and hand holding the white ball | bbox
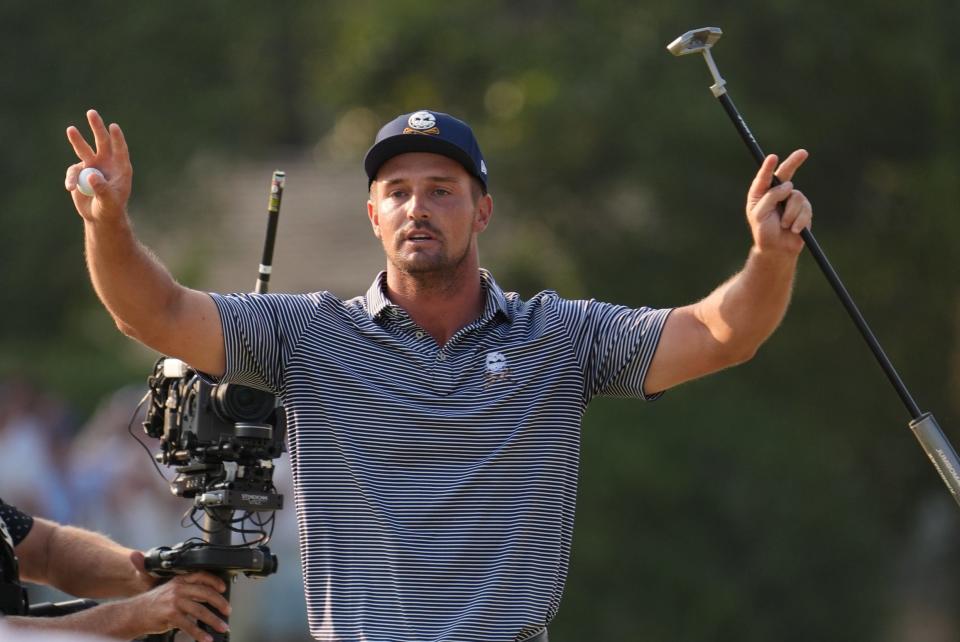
[64,109,226,376]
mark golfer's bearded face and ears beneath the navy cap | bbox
[367,152,493,274]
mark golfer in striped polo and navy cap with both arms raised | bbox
[66,110,812,642]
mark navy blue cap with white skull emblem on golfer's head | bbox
[363,109,487,189]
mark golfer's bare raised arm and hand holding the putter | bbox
[644,150,813,394]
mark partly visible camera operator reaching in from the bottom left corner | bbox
[0,500,230,641]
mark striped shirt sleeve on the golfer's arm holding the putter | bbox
[556,298,673,401]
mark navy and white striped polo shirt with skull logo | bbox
[211,270,670,642]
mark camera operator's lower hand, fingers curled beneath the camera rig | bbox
[124,572,230,641]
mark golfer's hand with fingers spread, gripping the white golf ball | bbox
[64,109,133,223]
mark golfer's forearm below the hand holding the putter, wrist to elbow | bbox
[695,247,797,363]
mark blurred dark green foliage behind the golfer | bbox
[0,0,960,642]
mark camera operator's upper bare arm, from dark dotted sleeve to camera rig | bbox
[16,518,156,598]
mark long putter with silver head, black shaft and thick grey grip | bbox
[667,27,960,504]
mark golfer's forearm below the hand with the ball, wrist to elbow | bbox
[84,215,183,347]
